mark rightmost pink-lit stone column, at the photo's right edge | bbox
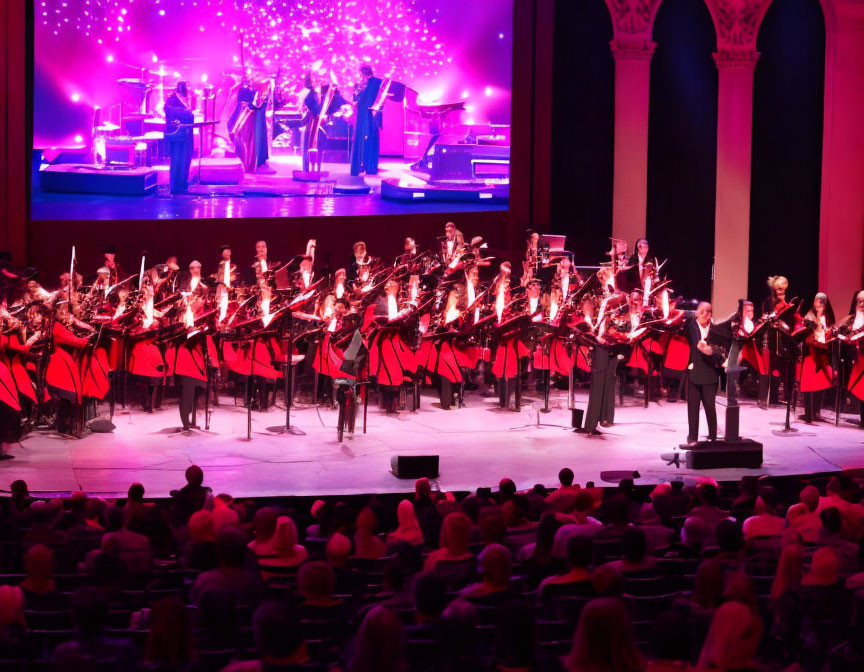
[819,0,864,300]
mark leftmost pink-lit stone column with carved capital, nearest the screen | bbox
[611,39,657,246]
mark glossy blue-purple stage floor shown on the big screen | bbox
[31,156,508,221]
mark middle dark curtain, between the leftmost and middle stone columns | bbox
[644,0,717,299]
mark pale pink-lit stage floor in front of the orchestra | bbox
[0,391,864,497]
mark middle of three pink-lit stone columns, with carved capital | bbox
[711,49,759,316]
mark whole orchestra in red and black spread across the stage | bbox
[0,226,864,452]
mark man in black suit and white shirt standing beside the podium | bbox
[686,301,722,444]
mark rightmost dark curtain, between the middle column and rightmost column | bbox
[748,0,824,306]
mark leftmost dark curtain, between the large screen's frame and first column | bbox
[550,0,615,264]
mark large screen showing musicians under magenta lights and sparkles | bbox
[31,0,513,220]
